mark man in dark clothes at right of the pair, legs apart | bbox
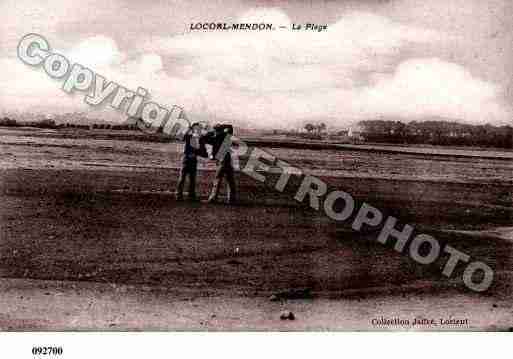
[205,124,237,204]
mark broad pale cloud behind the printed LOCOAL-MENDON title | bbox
[146,9,436,93]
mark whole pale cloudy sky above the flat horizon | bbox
[0,0,513,128]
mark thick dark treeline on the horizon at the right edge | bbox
[359,120,513,148]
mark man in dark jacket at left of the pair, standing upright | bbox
[176,123,208,201]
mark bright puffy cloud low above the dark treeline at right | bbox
[362,58,507,123]
